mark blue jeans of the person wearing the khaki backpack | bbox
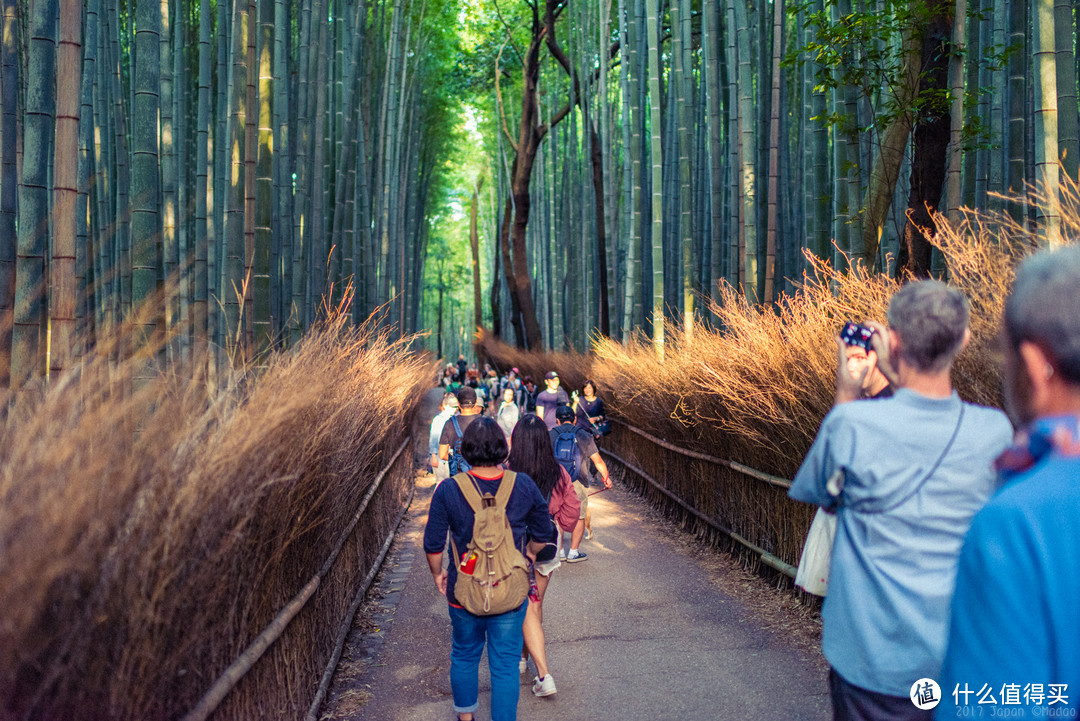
[449,601,528,721]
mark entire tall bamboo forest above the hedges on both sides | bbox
[0,0,1080,369]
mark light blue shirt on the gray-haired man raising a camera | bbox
[788,389,1012,696]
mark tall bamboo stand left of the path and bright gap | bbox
[0,0,454,387]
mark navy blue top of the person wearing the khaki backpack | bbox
[423,473,555,606]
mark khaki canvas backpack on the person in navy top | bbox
[450,471,529,616]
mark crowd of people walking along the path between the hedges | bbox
[423,369,611,721]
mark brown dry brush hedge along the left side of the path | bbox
[0,319,432,720]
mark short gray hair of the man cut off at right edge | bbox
[1004,246,1080,383]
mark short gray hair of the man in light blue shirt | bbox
[889,281,971,372]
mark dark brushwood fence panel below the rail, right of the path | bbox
[600,418,812,579]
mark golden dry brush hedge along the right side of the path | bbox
[478,203,1058,563]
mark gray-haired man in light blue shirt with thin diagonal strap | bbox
[788,281,1012,721]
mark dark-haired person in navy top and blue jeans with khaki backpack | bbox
[423,417,555,721]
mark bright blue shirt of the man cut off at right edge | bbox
[937,416,1080,719]
